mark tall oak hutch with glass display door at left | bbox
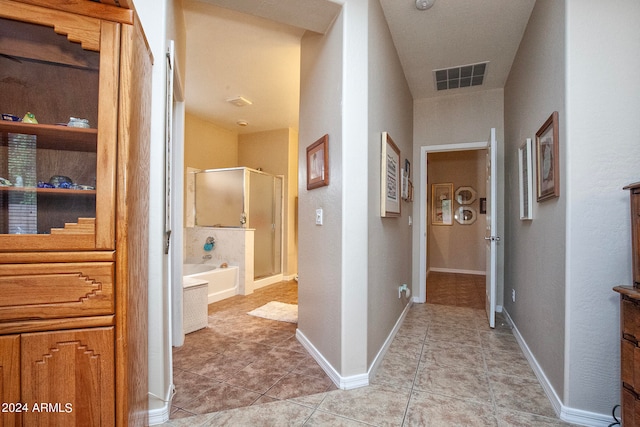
[0,0,152,426]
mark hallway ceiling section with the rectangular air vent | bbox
[380,0,535,99]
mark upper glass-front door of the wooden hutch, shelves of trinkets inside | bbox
[0,0,121,252]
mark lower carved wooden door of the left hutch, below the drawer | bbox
[21,327,115,427]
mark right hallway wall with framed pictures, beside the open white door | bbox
[504,0,568,404]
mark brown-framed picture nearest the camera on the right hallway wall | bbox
[536,111,560,202]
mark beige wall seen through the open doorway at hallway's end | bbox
[427,150,486,273]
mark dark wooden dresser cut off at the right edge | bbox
[613,182,640,427]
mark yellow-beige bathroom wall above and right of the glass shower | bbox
[238,129,298,276]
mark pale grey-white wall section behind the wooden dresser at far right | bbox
[565,0,640,414]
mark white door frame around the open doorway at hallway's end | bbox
[415,141,488,303]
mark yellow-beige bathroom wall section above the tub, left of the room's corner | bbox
[184,113,238,171]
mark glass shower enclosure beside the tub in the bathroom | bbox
[194,167,284,280]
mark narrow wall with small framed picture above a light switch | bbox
[298,8,344,371]
